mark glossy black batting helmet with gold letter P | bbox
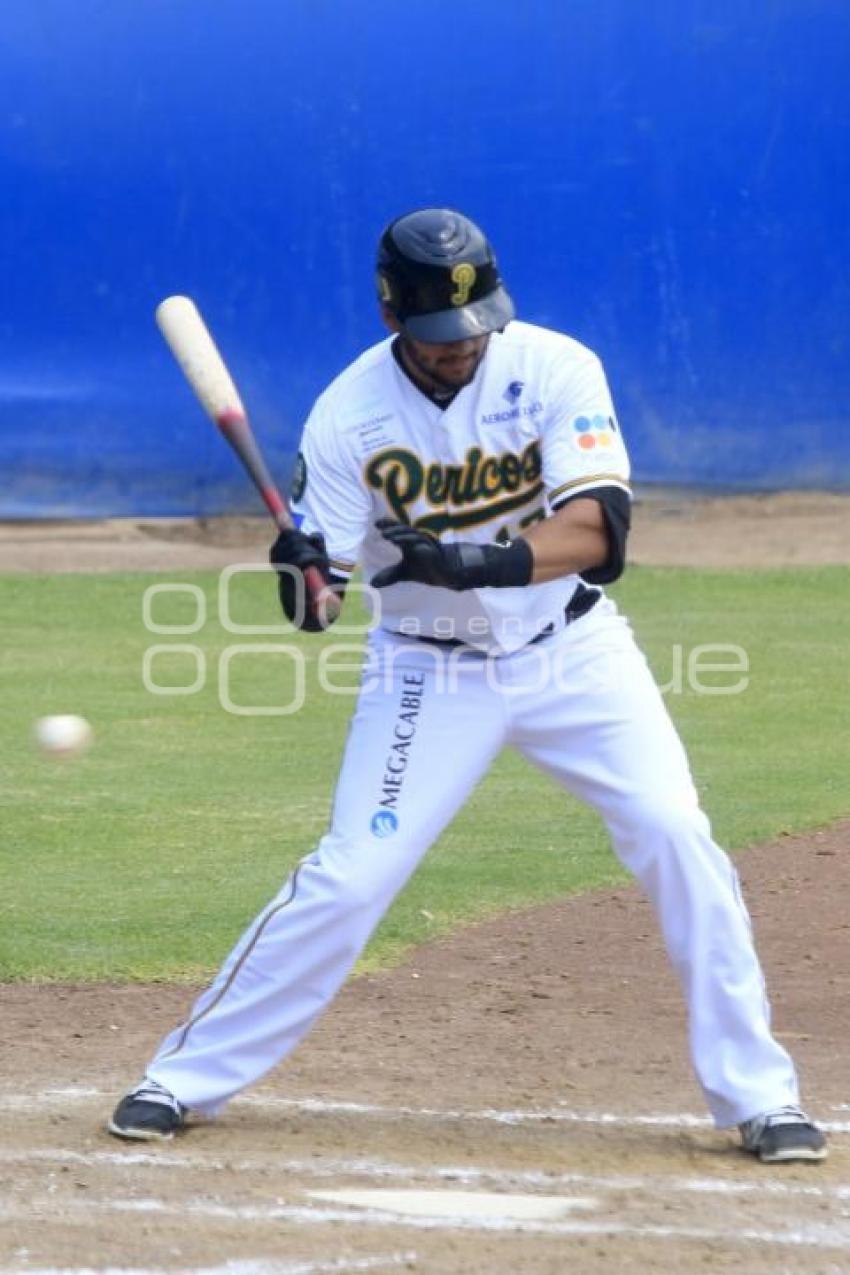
[377,208,514,344]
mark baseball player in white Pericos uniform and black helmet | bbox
[108,208,827,1162]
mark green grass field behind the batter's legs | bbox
[0,567,850,980]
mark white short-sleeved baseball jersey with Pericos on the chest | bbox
[293,321,628,654]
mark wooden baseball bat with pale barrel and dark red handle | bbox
[157,296,339,623]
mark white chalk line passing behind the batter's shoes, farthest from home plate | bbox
[0,1089,850,1133]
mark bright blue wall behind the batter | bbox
[0,0,850,518]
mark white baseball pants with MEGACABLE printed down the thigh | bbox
[147,601,799,1127]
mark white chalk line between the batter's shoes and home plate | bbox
[0,1146,850,1198]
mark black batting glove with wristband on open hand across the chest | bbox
[372,518,534,592]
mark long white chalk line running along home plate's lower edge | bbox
[0,1199,850,1244]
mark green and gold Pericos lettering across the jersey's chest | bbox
[366,440,543,536]
